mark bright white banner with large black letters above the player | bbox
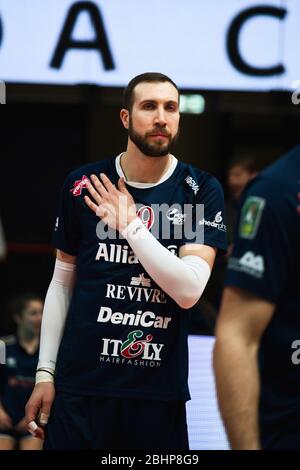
[0,0,300,90]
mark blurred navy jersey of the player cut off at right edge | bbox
[226,146,300,446]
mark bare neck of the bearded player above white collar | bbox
[120,147,172,183]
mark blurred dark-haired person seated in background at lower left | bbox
[0,293,43,450]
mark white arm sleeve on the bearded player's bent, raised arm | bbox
[122,218,211,308]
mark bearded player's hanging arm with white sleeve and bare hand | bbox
[25,250,76,438]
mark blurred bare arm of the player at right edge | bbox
[214,287,274,450]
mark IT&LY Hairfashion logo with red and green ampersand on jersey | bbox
[100,330,164,367]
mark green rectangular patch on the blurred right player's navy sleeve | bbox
[239,196,266,240]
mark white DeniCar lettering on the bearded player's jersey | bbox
[97,306,172,330]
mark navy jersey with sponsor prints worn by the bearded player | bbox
[54,156,226,400]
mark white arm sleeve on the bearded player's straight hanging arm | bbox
[36,259,76,383]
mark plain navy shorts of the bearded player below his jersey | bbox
[44,392,189,450]
